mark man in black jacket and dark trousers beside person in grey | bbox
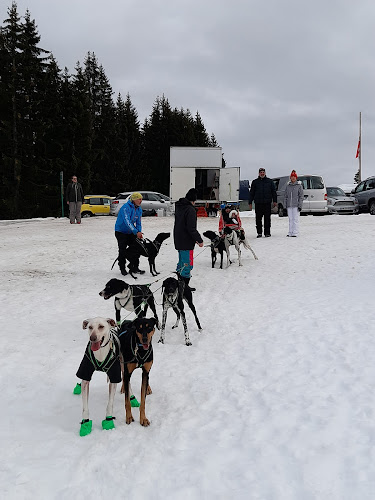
[249,167,277,238]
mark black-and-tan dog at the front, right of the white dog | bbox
[119,318,157,427]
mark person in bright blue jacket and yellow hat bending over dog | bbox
[115,193,144,276]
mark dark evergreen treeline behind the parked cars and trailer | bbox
[0,2,222,219]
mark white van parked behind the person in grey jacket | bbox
[272,175,328,217]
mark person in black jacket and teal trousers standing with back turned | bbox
[173,188,203,285]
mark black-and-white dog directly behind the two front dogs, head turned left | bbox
[99,278,159,328]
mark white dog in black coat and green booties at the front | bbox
[77,317,122,436]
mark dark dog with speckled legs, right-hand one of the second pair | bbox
[159,278,202,345]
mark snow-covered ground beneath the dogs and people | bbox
[0,214,375,500]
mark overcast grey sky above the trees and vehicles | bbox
[0,0,375,185]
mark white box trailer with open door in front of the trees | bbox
[169,146,240,204]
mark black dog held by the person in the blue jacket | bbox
[125,233,171,279]
